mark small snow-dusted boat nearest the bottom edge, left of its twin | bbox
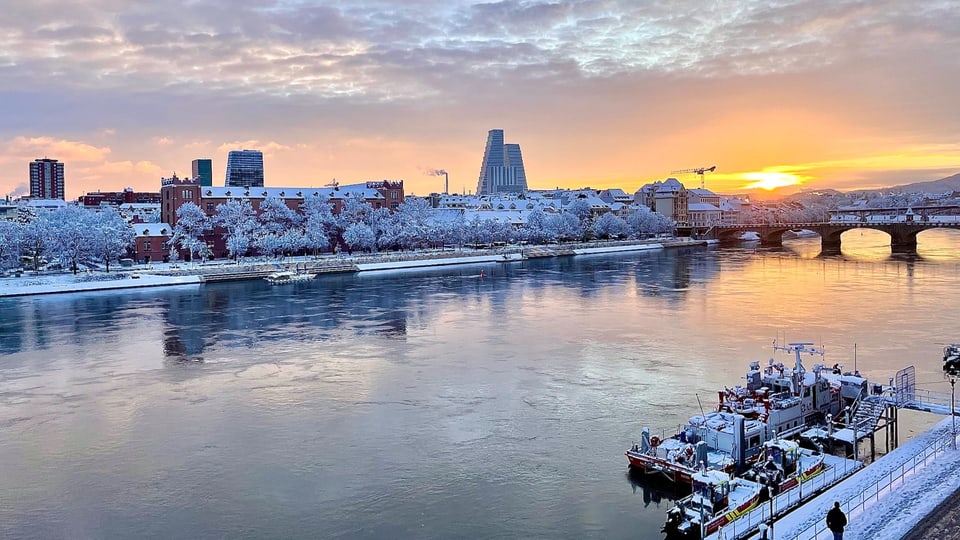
[663,470,764,540]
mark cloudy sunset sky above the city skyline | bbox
[0,0,960,198]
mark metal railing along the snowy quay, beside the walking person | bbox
[780,434,953,540]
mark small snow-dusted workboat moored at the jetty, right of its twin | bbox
[741,439,826,496]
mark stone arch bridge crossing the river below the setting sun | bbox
[698,221,960,252]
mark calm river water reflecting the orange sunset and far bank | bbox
[0,231,960,539]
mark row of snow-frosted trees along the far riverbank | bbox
[0,196,676,273]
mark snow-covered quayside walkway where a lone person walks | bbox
[754,417,960,540]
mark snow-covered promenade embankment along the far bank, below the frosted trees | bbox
[0,238,709,298]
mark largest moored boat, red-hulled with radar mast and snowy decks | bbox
[626,341,867,483]
